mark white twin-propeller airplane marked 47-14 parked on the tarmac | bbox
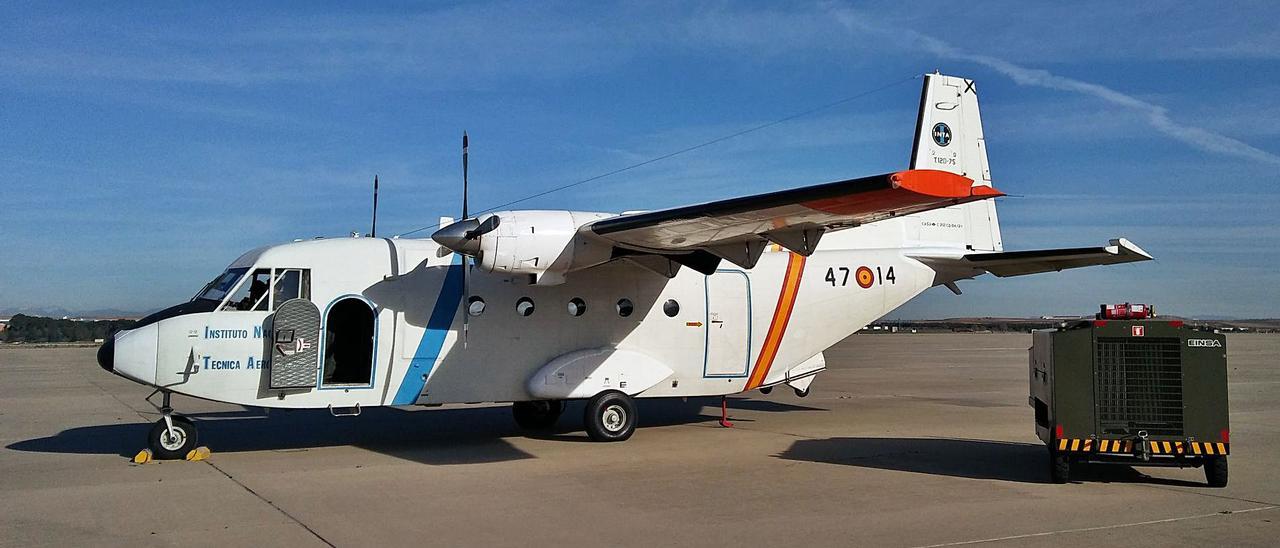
[97,73,1152,458]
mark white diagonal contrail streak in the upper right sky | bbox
[833,9,1280,165]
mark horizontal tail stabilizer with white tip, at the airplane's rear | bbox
[962,238,1152,278]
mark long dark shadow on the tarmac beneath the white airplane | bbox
[8,398,824,465]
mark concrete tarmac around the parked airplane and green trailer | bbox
[0,334,1280,547]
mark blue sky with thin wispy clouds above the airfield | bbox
[0,1,1280,318]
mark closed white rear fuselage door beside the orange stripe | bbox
[703,270,751,376]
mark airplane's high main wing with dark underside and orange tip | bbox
[579,169,1004,274]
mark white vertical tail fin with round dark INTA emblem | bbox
[911,74,1004,251]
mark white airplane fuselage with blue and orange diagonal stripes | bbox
[114,218,934,407]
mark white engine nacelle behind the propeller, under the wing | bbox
[476,210,613,286]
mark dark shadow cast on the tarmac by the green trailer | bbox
[777,438,1203,487]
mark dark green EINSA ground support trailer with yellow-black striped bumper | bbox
[1028,307,1231,487]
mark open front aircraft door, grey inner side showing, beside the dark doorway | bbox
[268,298,320,389]
